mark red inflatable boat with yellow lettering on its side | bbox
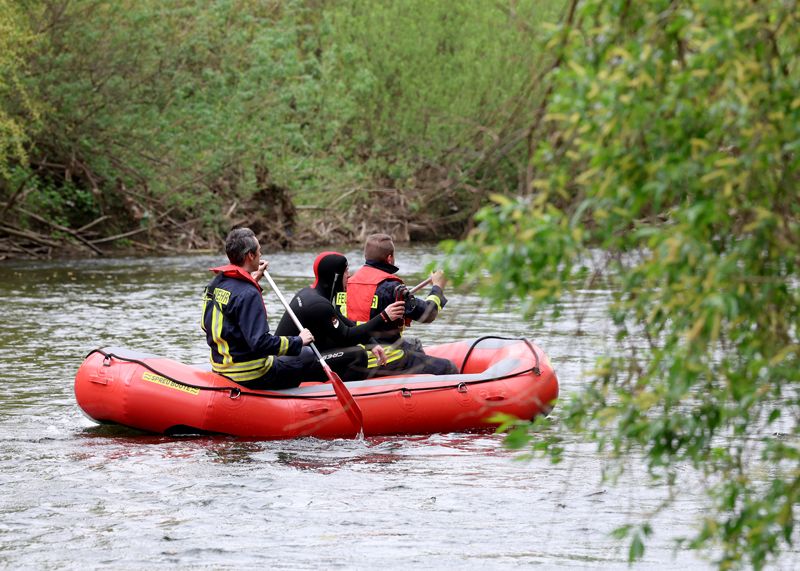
[75,337,558,439]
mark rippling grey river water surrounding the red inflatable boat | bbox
[0,248,796,569]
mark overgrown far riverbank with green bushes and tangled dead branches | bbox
[0,0,562,256]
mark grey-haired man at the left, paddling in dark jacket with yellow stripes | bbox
[202,228,318,389]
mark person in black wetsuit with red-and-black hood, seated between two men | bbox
[275,252,404,381]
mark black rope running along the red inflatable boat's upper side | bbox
[86,335,542,400]
